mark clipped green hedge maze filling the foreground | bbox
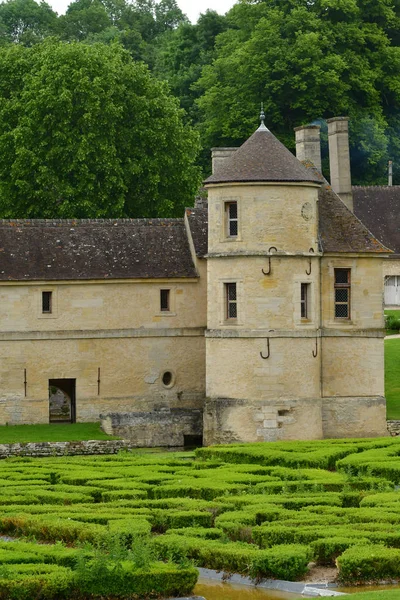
[0,438,400,600]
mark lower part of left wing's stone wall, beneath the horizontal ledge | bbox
[0,336,205,425]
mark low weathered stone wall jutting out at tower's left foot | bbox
[100,408,203,448]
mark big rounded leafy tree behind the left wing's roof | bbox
[0,40,199,218]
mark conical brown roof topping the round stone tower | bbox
[204,124,321,184]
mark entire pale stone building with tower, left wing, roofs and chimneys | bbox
[0,118,391,446]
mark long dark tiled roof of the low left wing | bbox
[0,219,197,281]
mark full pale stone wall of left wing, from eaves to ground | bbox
[0,277,206,424]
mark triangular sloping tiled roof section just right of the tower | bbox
[319,184,390,253]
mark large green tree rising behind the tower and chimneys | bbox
[196,0,400,183]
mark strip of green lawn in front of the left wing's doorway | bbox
[0,423,118,444]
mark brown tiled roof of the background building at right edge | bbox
[353,185,400,254]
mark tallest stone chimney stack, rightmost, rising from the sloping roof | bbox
[327,117,353,212]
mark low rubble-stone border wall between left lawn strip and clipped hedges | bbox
[0,440,135,459]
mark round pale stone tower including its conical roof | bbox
[204,122,322,444]
